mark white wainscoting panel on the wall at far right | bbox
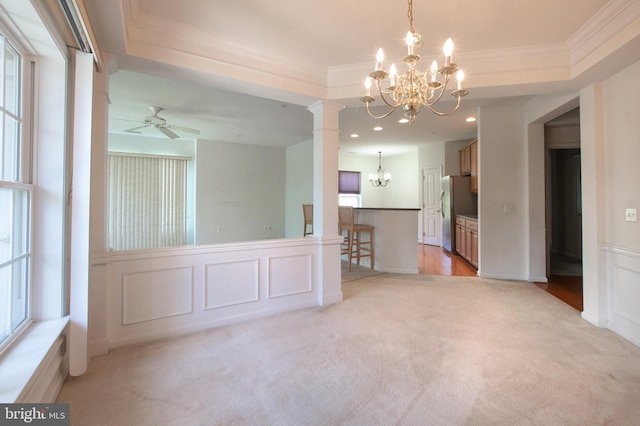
[607,247,640,346]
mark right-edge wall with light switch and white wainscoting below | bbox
[596,62,640,345]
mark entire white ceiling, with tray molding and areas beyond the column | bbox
[84,0,640,155]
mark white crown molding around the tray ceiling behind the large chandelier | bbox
[121,0,640,104]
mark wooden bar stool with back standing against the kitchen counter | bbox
[338,206,375,272]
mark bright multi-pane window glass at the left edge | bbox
[0,30,33,349]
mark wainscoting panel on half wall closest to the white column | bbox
[269,255,312,299]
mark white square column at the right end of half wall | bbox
[309,101,344,306]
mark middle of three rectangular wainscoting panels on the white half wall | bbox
[205,259,259,309]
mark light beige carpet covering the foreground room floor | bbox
[59,274,640,425]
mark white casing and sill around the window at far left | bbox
[0,0,70,402]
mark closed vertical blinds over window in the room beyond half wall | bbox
[107,153,188,250]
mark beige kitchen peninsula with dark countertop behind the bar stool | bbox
[354,207,420,274]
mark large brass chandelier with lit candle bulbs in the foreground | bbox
[360,0,469,123]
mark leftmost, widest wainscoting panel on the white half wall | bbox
[122,267,193,325]
